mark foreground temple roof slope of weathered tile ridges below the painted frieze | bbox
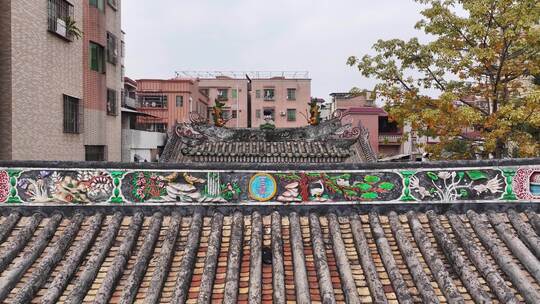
[0,204,540,303]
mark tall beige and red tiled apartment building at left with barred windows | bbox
[0,0,122,161]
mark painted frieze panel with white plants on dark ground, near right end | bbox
[409,169,506,202]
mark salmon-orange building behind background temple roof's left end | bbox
[137,79,209,132]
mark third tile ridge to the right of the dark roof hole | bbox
[309,213,336,304]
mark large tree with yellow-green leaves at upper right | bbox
[347,0,540,158]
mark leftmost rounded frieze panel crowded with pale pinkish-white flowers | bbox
[17,170,113,204]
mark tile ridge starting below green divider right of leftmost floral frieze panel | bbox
[66,212,123,304]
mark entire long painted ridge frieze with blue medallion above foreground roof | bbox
[0,167,540,204]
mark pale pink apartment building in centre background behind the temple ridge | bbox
[177,71,311,128]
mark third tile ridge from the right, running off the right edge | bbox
[487,210,540,282]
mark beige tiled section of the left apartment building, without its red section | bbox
[0,0,84,160]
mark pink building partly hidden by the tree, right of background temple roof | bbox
[330,92,404,158]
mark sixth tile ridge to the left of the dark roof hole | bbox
[120,212,163,304]
